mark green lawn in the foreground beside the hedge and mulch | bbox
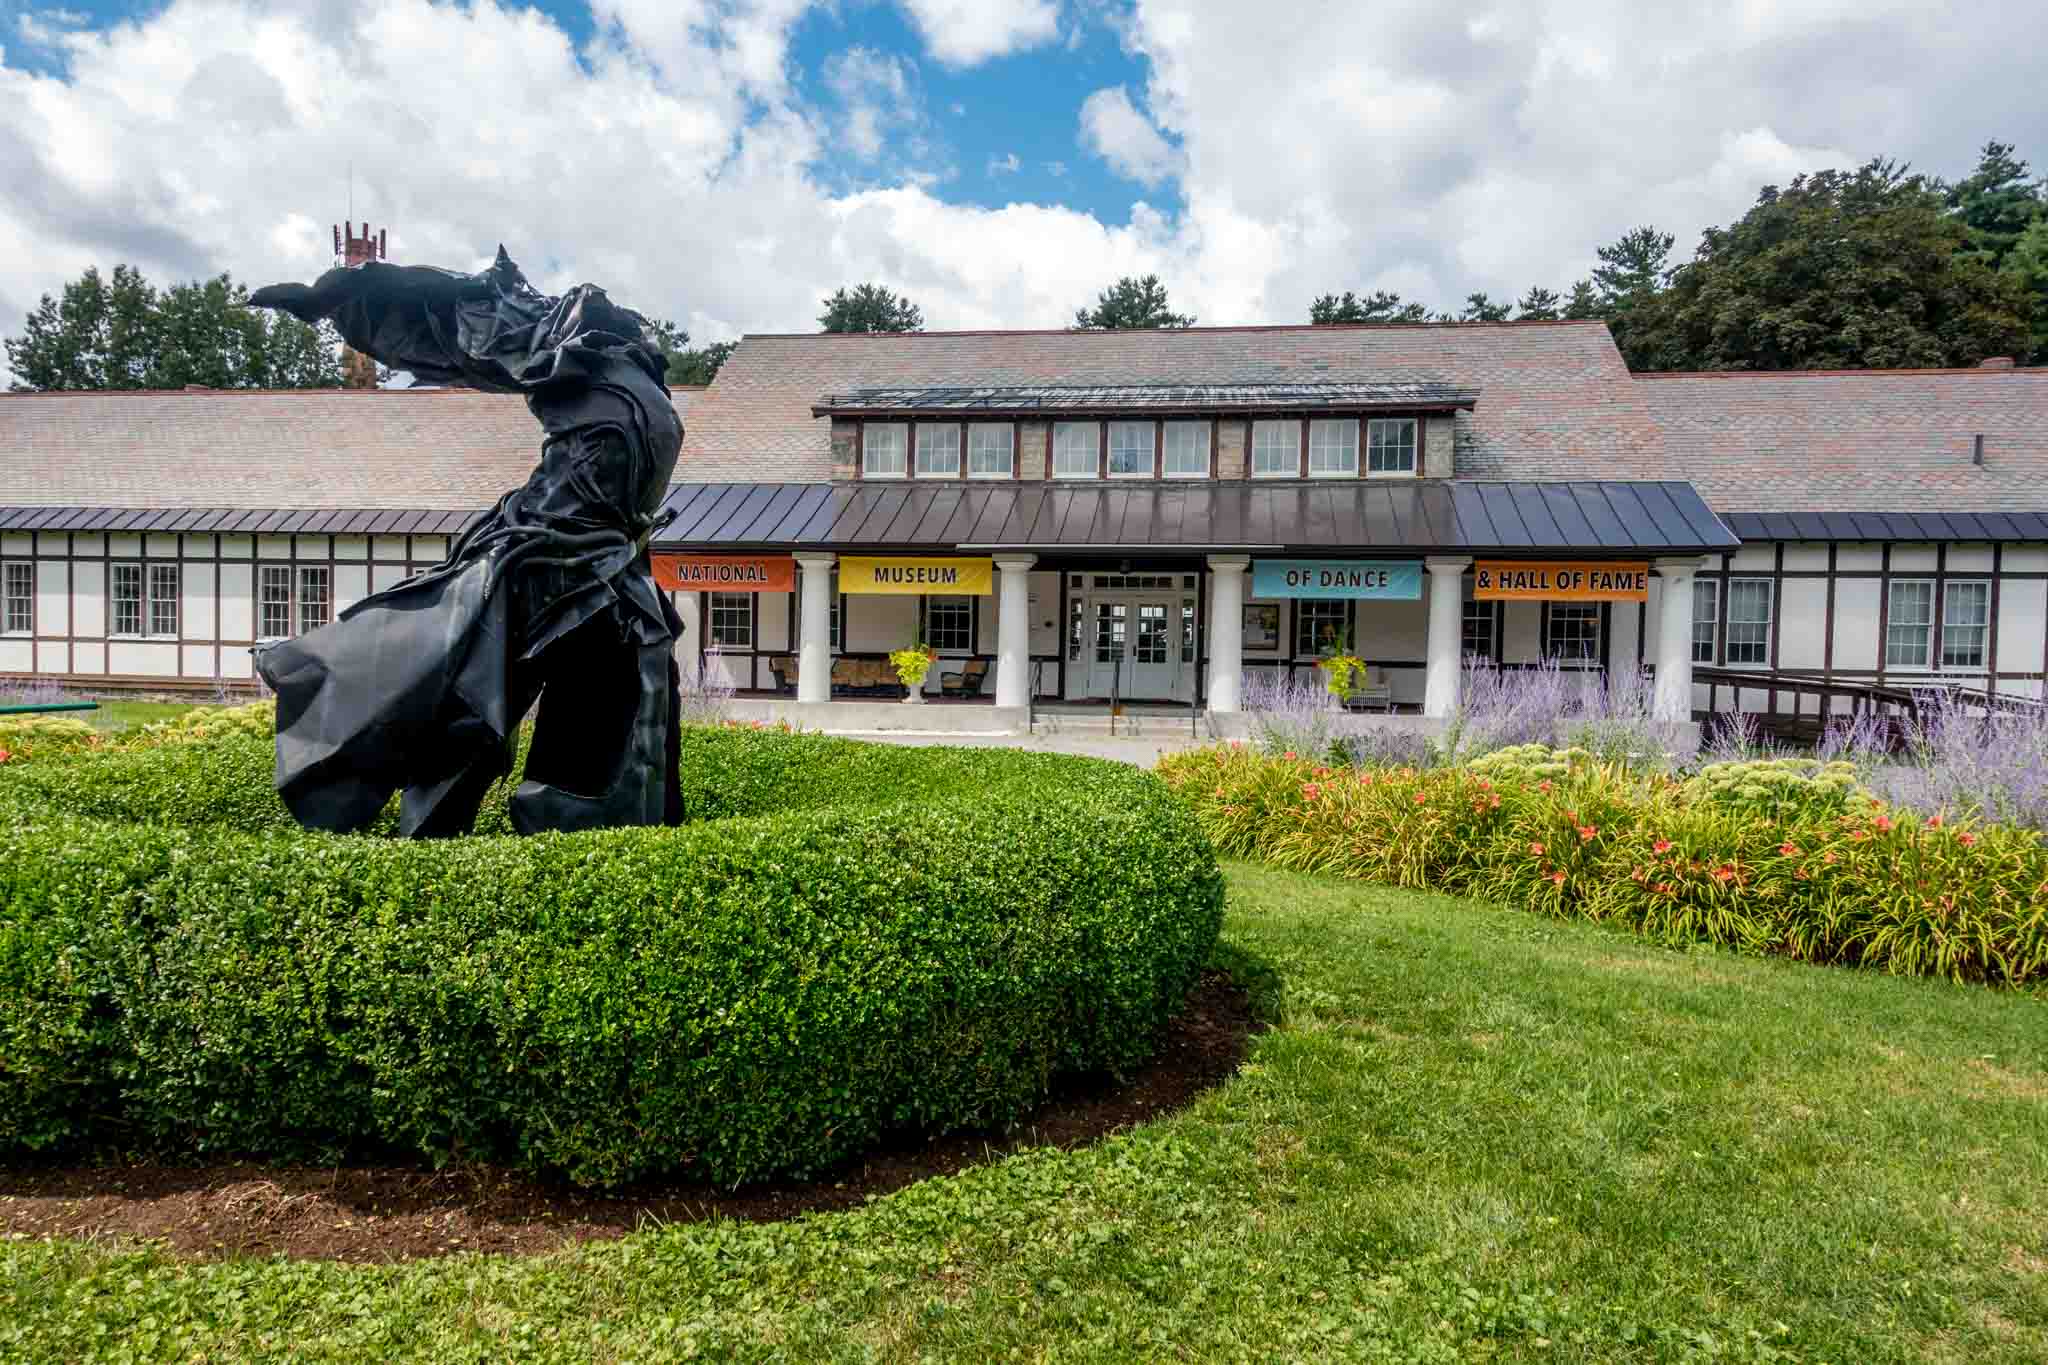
[0,868,2048,1363]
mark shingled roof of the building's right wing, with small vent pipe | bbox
[1636,368,2048,512]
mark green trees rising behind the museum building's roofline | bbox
[4,141,2048,389]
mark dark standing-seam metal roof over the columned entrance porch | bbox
[655,479,1741,555]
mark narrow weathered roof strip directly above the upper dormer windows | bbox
[811,383,1479,417]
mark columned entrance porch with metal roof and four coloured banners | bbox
[655,481,1731,726]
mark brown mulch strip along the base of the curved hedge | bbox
[0,974,1260,1263]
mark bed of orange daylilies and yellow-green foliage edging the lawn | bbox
[1159,745,2048,982]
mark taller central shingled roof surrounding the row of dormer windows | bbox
[676,323,1669,483]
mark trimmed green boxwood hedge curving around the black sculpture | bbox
[0,731,1223,1185]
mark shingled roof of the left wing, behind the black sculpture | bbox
[0,389,698,512]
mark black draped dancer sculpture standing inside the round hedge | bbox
[250,248,682,837]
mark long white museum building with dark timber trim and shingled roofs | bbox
[0,323,2048,732]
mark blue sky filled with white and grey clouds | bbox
[0,0,2048,351]
